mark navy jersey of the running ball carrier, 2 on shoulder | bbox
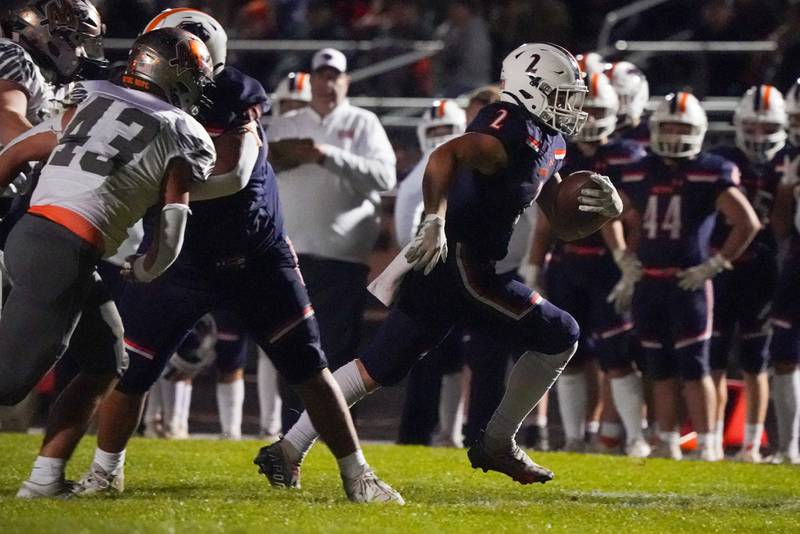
[445,102,567,260]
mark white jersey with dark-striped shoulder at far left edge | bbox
[0,38,55,124]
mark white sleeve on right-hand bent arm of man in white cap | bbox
[322,115,397,194]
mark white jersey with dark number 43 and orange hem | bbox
[31,81,216,257]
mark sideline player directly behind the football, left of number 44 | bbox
[534,72,650,458]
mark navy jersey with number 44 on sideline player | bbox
[621,152,739,268]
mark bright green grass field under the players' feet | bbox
[0,434,800,534]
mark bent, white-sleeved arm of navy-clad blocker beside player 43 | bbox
[190,123,261,200]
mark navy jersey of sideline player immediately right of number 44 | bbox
[711,145,795,258]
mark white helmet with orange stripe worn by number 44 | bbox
[650,91,708,158]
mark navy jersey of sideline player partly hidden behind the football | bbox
[555,139,646,253]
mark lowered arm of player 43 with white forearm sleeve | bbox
[130,158,192,282]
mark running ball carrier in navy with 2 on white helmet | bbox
[265,44,622,484]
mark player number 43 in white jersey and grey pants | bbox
[0,30,215,498]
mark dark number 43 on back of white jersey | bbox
[50,96,161,176]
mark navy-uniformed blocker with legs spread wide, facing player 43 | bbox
[76,8,403,504]
